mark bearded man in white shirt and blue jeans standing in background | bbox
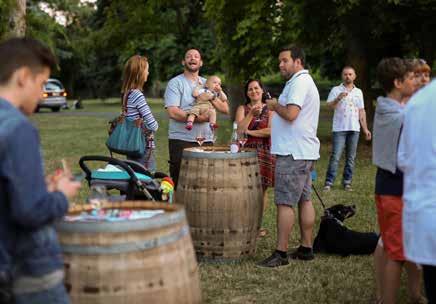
[324,66,371,191]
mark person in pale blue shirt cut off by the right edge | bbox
[397,81,436,303]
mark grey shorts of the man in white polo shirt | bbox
[274,155,314,207]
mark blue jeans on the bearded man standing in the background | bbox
[325,131,359,186]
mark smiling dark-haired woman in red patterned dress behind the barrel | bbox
[235,79,274,235]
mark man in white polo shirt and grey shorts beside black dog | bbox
[258,46,320,267]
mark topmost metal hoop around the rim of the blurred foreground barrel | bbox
[56,209,186,233]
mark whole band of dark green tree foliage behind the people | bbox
[0,0,436,102]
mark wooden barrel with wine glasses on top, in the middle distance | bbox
[176,147,262,261]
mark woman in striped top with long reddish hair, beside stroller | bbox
[121,55,158,172]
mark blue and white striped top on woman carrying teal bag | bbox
[126,90,159,132]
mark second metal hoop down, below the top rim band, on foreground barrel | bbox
[62,225,189,255]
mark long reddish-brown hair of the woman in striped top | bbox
[121,55,148,94]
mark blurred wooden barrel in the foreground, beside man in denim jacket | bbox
[57,201,201,304]
